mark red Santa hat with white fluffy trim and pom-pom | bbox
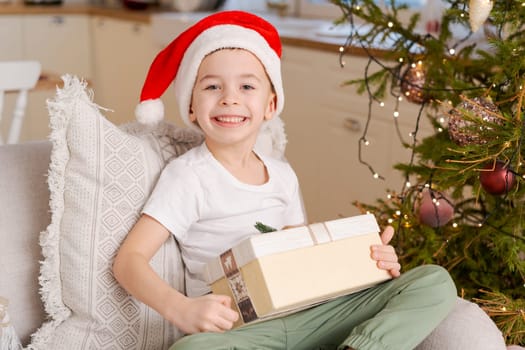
[135,11,285,134]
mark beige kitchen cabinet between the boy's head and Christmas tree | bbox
[282,45,431,222]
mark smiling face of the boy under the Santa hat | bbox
[190,49,276,147]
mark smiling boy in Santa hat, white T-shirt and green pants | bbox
[114,11,456,350]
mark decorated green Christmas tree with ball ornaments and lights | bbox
[333,0,525,345]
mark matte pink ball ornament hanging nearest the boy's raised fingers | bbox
[419,190,454,227]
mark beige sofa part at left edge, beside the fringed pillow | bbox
[0,141,51,343]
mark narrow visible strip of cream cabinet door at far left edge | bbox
[0,15,24,61]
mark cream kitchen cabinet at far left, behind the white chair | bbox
[0,14,92,141]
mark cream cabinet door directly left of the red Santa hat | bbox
[92,17,160,124]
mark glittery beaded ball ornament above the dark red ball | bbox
[448,97,502,146]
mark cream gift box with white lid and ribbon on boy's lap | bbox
[204,214,391,327]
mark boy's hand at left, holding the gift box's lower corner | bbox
[173,294,239,334]
